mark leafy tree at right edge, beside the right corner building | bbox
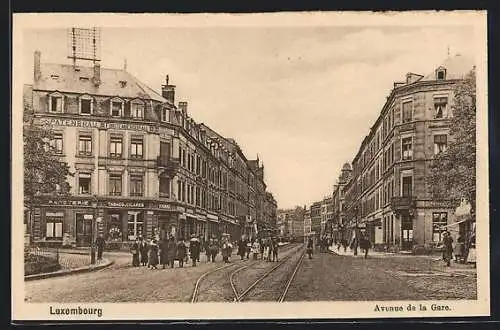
[428,70,476,214]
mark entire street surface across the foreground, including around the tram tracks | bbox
[26,245,477,302]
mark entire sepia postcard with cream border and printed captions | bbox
[11,11,490,322]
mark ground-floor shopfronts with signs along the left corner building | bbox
[26,198,241,246]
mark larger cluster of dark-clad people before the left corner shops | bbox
[130,235,201,269]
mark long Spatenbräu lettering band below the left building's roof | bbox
[38,118,158,132]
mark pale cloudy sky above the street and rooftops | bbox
[23,26,474,208]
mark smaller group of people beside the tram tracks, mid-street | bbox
[238,237,279,262]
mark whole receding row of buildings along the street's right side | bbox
[278,54,474,251]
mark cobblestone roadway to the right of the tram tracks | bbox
[287,253,477,301]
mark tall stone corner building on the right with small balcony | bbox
[337,55,474,250]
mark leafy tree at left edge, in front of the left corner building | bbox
[23,102,73,240]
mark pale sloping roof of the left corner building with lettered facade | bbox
[33,63,168,103]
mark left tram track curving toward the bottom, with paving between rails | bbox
[190,245,302,303]
